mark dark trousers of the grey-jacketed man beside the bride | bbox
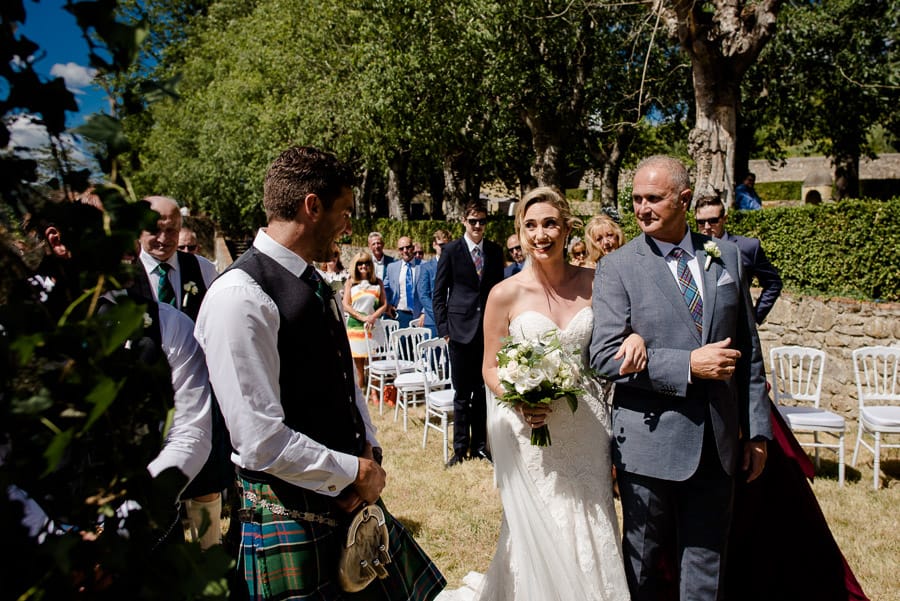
[617,422,734,601]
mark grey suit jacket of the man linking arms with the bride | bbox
[591,234,771,481]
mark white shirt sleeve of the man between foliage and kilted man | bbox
[147,303,212,480]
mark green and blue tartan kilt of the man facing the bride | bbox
[238,478,447,601]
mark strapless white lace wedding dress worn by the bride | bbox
[438,307,629,601]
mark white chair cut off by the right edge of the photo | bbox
[851,346,900,490]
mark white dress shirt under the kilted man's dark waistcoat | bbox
[194,229,379,496]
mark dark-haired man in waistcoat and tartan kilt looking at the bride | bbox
[195,147,446,601]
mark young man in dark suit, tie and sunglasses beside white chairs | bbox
[432,202,503,467]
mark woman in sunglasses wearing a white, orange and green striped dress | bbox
[342,252,387,390]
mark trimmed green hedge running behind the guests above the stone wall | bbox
[350,197,900,302]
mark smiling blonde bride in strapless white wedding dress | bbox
[468,187,646,601]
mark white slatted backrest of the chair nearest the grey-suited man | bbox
[769,346,825,407]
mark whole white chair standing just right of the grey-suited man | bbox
[769,346,847,486]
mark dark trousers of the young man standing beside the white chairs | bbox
[449,333,487,457]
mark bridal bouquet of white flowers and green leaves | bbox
[497,329,584,447]
